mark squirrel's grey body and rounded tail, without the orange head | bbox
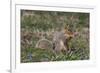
[36,31,68,52]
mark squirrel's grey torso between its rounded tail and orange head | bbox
[53,31,67,52]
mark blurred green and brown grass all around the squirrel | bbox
[20,10,90,63]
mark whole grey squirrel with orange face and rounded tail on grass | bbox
[36,29,77,52]
